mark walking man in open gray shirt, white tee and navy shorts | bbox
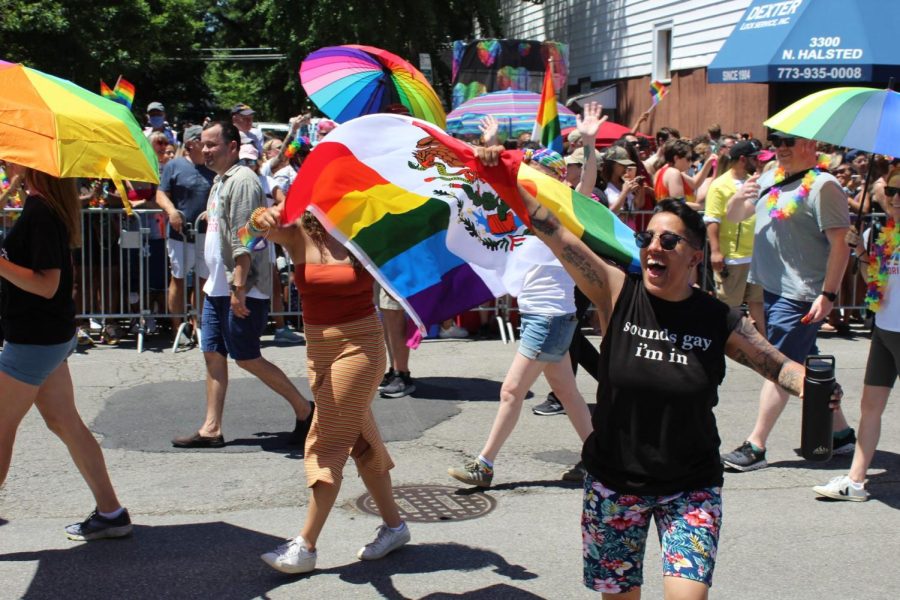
[172,122,312,448]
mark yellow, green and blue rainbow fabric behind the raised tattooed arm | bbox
[518,164,641,273]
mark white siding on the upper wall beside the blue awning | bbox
[501,0,751,85]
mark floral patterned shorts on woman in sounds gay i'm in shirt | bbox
[581,474,722,594]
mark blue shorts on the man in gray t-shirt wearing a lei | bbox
[763,291,823,364]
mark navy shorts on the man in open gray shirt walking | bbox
[200,296,269,360]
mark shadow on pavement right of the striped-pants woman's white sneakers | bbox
[321,543,540,600]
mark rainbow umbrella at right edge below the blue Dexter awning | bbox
[765,87,900,156]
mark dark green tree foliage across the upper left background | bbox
[0,0,502,120]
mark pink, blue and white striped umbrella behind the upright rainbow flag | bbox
[447,90,575,138]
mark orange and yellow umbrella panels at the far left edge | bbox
[0,61,159,183]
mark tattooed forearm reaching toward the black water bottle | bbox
[725,317,806,396]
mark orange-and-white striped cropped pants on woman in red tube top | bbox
[303,314,394,487]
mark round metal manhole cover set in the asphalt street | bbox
[356,485,497,523]
